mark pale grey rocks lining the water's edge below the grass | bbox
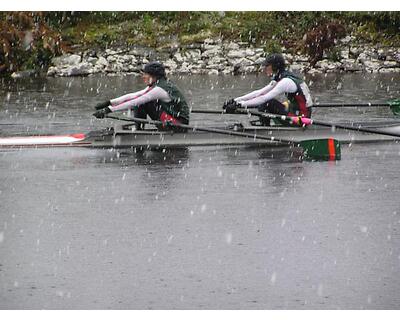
[14,36,400,77]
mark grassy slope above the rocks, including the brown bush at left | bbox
[0,12,400,74]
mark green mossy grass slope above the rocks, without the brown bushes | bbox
[58,12,400,47]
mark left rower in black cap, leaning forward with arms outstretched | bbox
[93,62,189,131]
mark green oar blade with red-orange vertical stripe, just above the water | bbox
[299,138,341,161]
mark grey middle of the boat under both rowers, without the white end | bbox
[86,125,400,149]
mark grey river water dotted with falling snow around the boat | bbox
[0,74,400,309]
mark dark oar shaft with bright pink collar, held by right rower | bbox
[236,109,400,137]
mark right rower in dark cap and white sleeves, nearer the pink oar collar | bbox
[223,54,313,126]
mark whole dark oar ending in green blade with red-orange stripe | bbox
[106,114,341,160]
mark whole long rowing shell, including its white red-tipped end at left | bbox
[0,122,400,149]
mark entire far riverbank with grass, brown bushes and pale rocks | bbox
[0,12,400,78]
